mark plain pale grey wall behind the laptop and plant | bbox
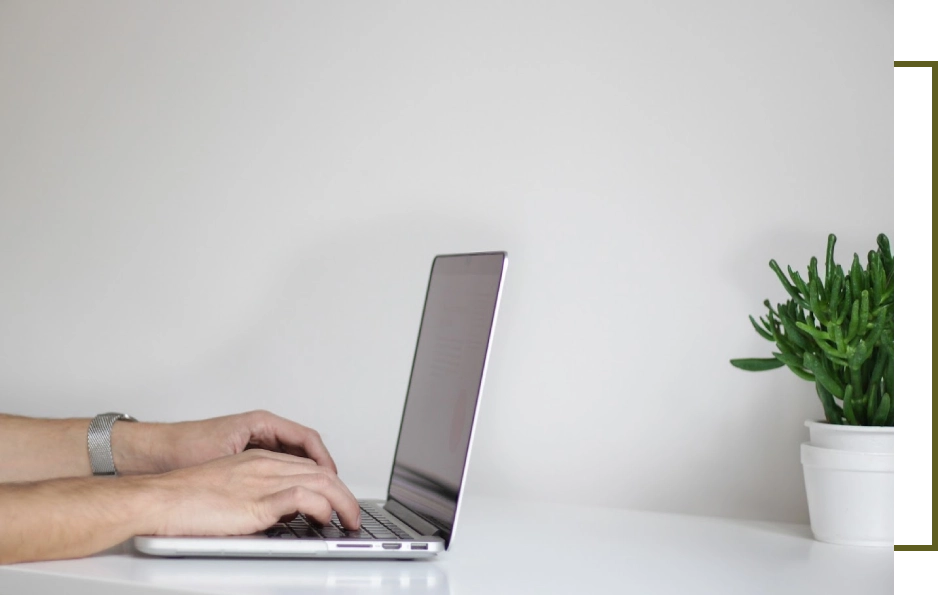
[0,0,896,522]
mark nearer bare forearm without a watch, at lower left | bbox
[0,476,165,564]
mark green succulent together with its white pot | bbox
[730,234,896,547]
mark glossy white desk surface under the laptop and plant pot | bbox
[0,498,896,595]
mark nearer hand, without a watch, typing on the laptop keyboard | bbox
[140,449,361,536]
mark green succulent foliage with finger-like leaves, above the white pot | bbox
[730,234,896,426]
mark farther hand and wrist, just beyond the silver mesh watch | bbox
[112,411,338,475]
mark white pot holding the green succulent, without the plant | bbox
[801,422,896,547]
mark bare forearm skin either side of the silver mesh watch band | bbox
[0,415,156,483]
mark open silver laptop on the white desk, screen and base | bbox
[134,252,508,559]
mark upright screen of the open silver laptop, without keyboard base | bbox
[388,253,505,533]
